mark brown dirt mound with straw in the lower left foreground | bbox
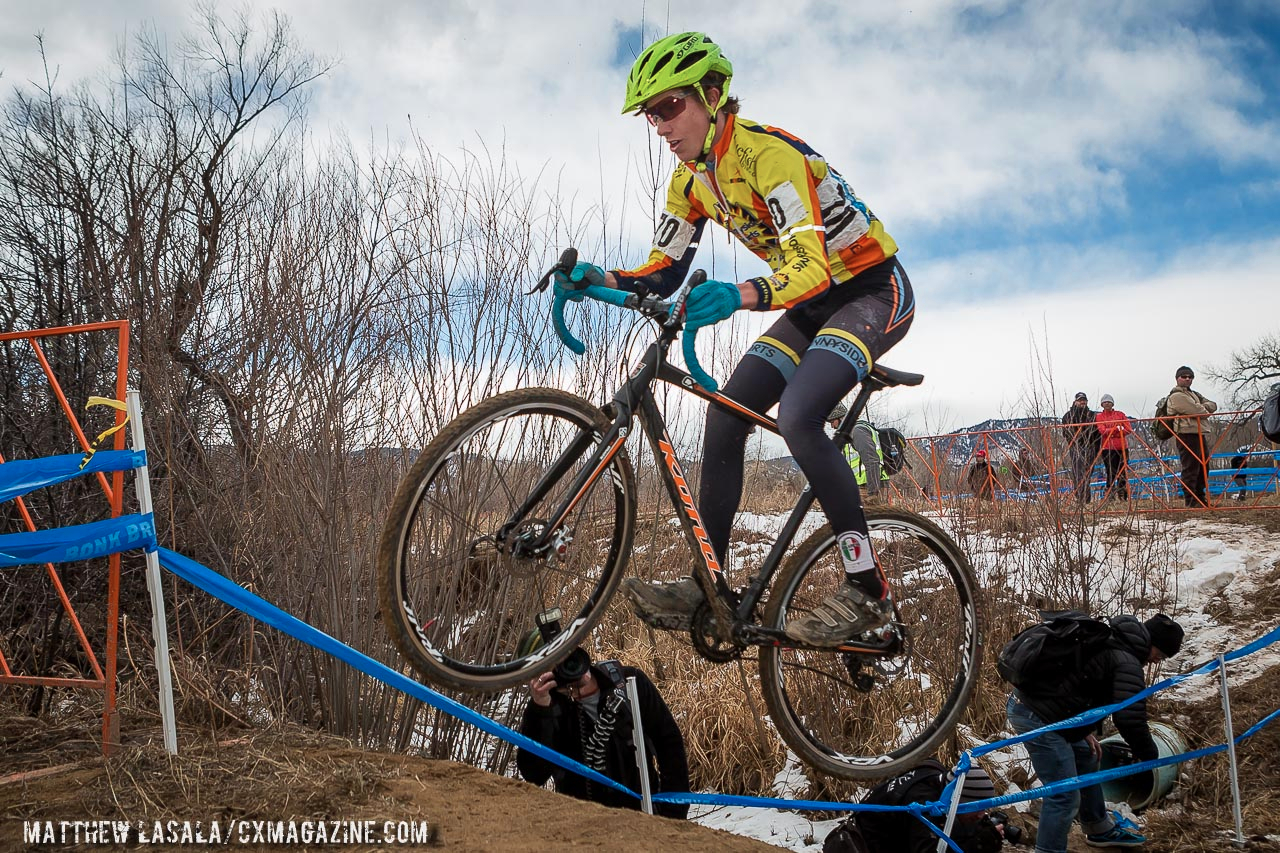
[0,716,777,853]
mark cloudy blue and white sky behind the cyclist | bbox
[0,0,1280,432]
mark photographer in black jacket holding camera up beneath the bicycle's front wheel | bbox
[516,650,689,820]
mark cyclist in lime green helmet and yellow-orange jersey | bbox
[556,32,915,646]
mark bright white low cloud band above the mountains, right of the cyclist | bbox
[886,234,1280,430]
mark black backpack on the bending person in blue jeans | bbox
[996,613,1114,695]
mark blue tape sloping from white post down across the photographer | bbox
[159,548,629,798]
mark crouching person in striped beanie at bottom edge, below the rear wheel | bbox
[822,758,1004,853]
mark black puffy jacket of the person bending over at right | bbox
[1014,616,1160,761]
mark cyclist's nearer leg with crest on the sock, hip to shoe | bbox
[778,260,914,643]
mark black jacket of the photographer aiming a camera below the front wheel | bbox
[516,665,689,818]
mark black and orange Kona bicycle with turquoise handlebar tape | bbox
[378,250,982,779]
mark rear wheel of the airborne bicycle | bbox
[760,508,982,779]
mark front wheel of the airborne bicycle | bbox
[378,388,635,692]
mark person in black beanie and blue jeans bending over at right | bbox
[1009,613,1183,853]
